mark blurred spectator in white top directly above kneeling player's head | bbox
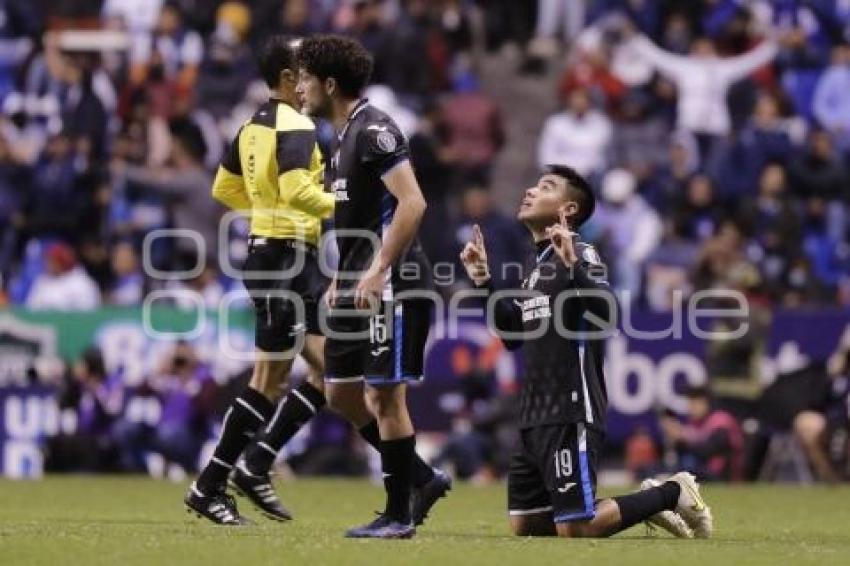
[537,89,613,176]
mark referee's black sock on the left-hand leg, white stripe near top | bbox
[196,387,274,495]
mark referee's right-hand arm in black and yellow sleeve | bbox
[277,130,335,218]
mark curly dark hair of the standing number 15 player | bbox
[297,35,373,98]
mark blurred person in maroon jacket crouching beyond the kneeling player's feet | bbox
[660,387,744,481]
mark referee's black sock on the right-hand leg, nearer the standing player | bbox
[245,381,325,475]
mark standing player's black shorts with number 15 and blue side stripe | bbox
[325,299,433,386]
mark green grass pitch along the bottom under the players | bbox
[0,477,850,566]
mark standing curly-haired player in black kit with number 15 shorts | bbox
[298,36,450,538]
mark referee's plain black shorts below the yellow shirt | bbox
[243,236,328,352]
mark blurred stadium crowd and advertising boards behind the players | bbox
[0,0,850,488]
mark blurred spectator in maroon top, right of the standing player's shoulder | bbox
[440,76,505,186]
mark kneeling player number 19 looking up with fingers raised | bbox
[461,166,712,538]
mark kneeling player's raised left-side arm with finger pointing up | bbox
[460,224,523,350]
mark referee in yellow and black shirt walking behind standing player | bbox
[184,37,334,525]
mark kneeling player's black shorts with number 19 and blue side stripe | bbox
[508,423,604,523]
